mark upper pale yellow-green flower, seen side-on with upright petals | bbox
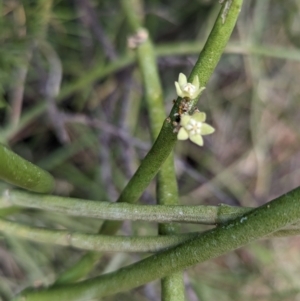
[175,73,205,99]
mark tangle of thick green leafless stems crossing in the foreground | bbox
[0,0,300,301]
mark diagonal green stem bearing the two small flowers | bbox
[31,0,242,282]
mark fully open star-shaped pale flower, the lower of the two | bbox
[177,112,215,146]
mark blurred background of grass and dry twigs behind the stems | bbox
[0,0,300,301]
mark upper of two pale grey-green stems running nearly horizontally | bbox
[0,188,253,225]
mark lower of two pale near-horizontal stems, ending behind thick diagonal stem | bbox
[0,218,199,253]
